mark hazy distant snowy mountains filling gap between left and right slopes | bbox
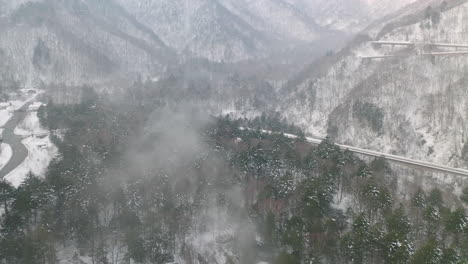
[116,0,413,62]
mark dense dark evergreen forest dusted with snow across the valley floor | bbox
[0,89,468,264]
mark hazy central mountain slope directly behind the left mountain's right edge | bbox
[114,0,269,61]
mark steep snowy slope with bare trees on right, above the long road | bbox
[280,1,468,167]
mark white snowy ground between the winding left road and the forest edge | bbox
[5,112,57,187]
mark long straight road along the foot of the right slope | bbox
[256,128,468,176]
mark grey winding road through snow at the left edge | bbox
[0,102,32,178]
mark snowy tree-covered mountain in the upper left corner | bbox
[0,0,172,86]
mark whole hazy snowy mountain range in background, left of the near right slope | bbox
[0,0,420,86]
